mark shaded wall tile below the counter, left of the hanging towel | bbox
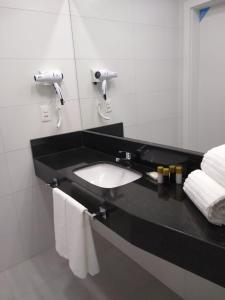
[13,183,54,257]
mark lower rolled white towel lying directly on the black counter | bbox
[184,170,225,225]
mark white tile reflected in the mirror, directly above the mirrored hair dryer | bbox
[72,16,133,59]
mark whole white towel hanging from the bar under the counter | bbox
[53,188,99,279]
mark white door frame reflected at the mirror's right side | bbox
[181,0,225,150]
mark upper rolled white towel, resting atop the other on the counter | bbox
[201,145,225,187]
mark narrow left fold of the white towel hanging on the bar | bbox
[53,188,68,258]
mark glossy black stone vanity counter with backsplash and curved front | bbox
[31,128,225,287]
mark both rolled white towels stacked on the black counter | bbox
[184,145,225,226]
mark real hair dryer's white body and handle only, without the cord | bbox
[34,71,64,105]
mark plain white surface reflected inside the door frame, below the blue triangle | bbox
[196,4,225,151]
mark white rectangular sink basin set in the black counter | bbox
[74,163,142,188]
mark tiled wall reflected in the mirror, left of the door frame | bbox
[69,0,181,145]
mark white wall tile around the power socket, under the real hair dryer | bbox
[0,100,80,151]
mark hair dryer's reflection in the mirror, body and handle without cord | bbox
[91,69,118,100]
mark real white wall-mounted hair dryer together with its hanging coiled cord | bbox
[34,71,64,128]
